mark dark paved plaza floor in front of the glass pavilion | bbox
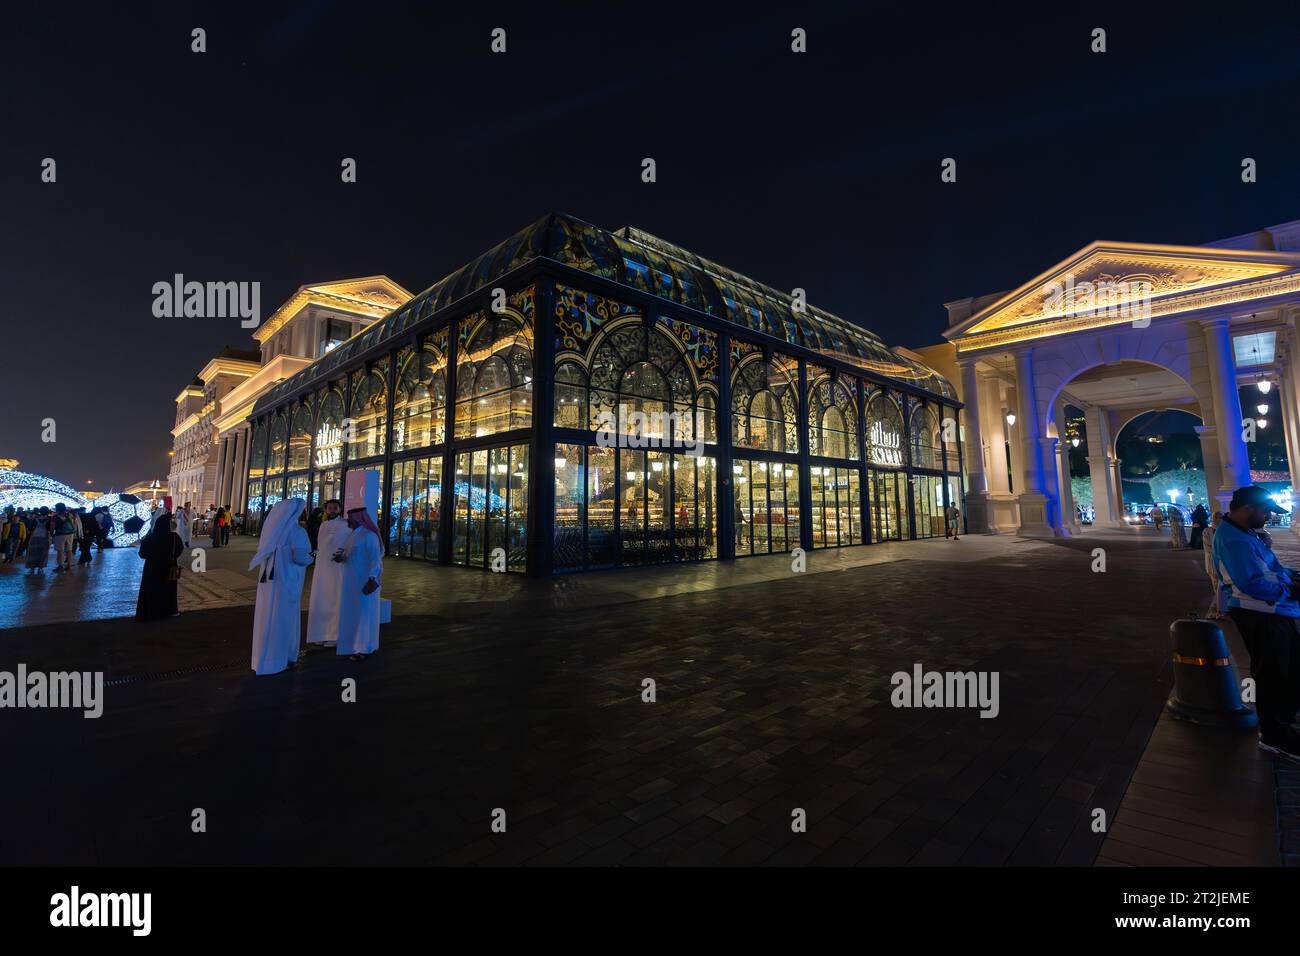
[0,532,1278,865]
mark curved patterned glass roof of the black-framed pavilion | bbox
[254,212,957,412]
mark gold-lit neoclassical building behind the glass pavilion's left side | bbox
[168,276,411,511]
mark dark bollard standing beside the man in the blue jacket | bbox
[1166,611,1260,730]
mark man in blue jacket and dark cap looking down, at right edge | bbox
[1213,485,1300,761]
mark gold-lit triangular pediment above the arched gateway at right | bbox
[944,242,1300,349]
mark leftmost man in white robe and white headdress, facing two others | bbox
[248,498,312,674]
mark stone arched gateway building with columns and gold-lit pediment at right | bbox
[944,222,1300,536]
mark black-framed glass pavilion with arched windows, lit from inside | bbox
[246,213,962,575]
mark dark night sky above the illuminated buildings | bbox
[0,0,1300,488]
